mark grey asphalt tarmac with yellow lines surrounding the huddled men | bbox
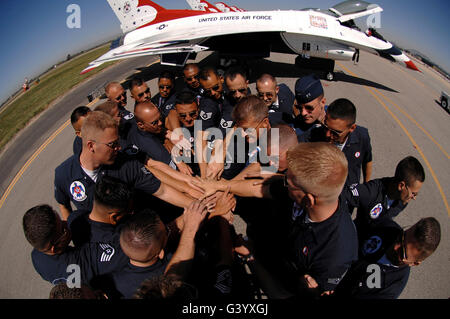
[0,52,450,299]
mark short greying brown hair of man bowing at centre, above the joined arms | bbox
[231,95,269,125]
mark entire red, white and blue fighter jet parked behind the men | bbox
[82,0,418,80]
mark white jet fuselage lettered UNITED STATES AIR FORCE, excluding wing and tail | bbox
[124,10,392,60]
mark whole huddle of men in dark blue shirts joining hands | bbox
[23,63,441,301]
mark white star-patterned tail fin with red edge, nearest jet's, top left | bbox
[108,0,166,33]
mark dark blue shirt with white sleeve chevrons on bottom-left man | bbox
[31,236,129,285]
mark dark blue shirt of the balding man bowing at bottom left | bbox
[112,257,169,299]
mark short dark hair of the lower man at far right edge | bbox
[413,217,441,259]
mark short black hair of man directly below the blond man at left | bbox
[94,176,133,209]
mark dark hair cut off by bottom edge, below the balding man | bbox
[133,275,198,302]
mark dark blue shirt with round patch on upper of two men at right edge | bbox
[342,177,408,237]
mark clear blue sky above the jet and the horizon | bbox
[0,0,450,103]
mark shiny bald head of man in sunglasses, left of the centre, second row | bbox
[134,102,163,134]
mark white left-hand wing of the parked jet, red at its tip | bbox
[81,41,208,74]
